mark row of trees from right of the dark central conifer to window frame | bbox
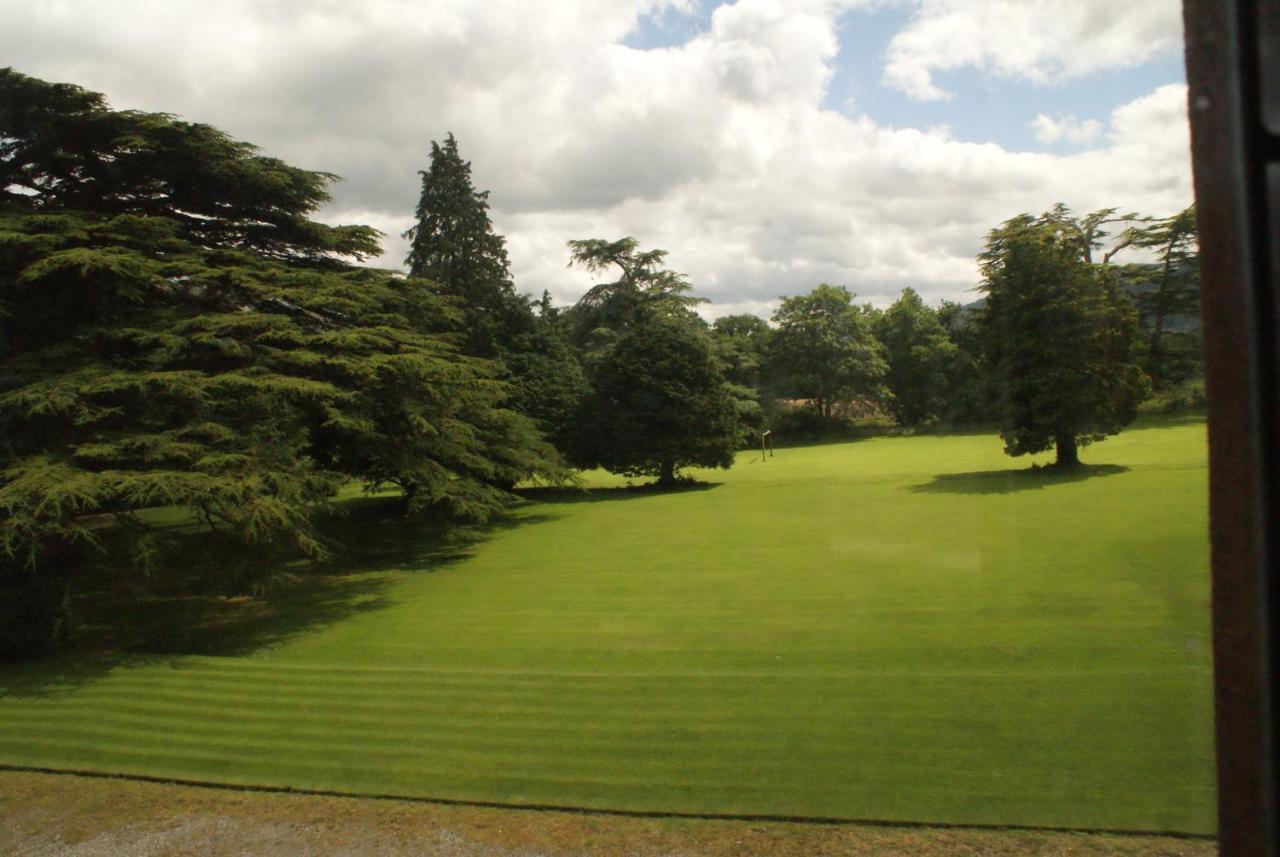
[713,199,1201,463]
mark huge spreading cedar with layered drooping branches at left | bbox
[0,69,559,654]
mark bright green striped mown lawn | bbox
[0,422,1213,833]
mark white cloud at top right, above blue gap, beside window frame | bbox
[884,0,1181,101]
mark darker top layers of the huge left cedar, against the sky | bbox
[0,69,379,263]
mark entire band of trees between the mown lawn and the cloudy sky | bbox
[0,69,1199,655]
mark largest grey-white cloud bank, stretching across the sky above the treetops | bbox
[0,0,1192,315]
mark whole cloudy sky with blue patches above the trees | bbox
[0,0,1192,317]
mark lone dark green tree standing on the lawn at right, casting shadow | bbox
[979,206,1149,466]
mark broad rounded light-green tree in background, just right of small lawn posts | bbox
[771,284,886,417]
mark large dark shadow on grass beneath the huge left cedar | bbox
[0,498,552,698]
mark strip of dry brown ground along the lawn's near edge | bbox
[0,770,1217,857]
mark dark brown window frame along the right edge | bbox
[1183,0,1280,857]
